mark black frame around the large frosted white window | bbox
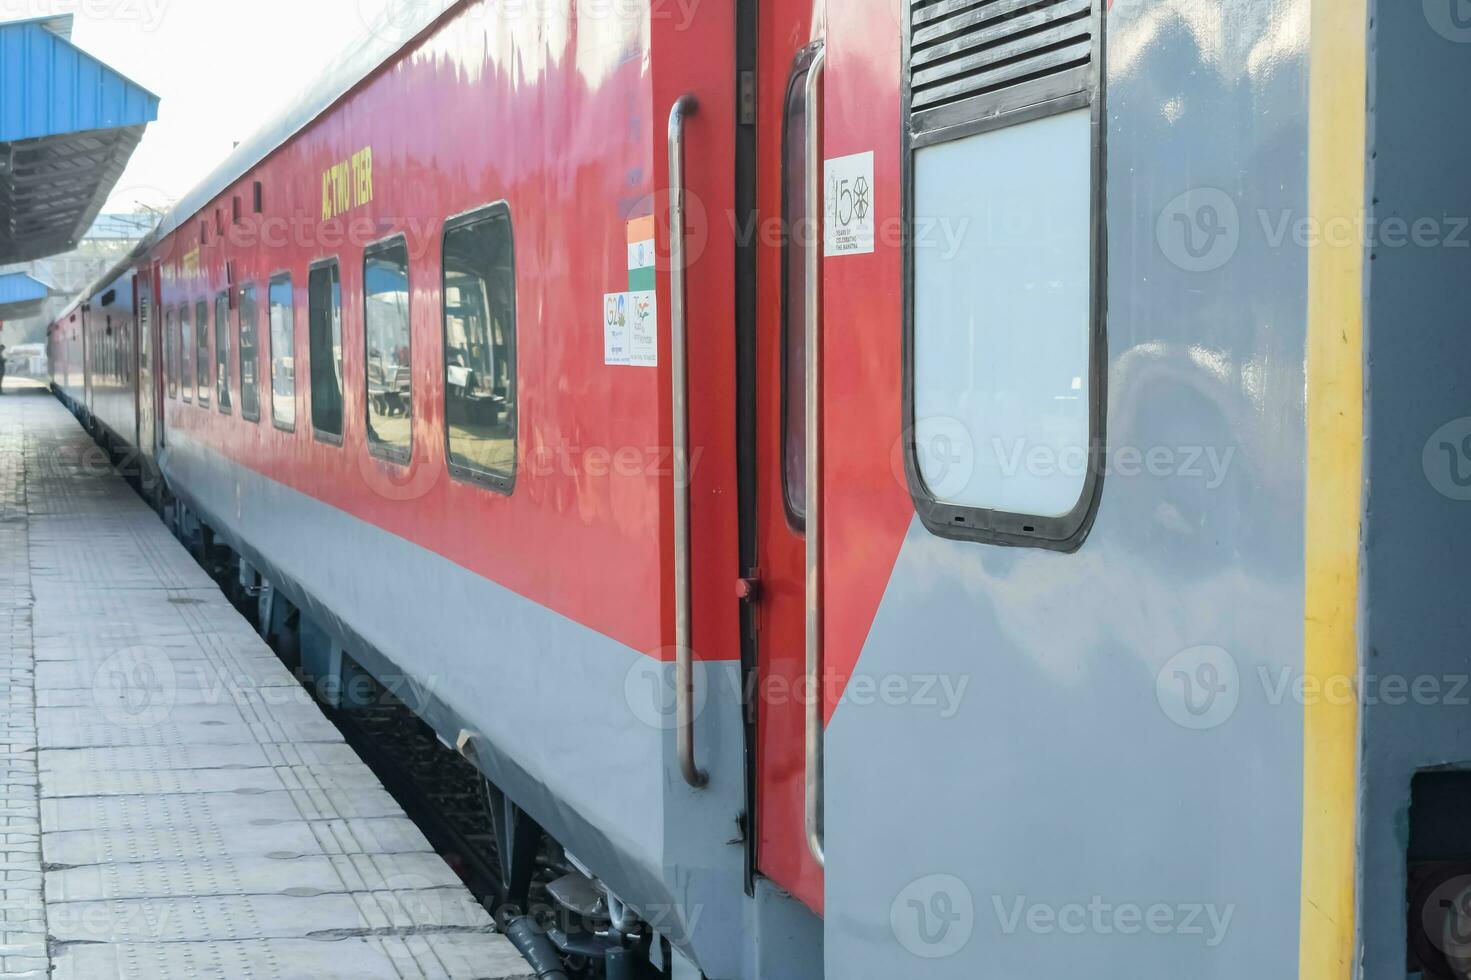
[900,0,1108,553]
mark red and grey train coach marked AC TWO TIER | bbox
[50,0,1471,980]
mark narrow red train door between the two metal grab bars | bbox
[750,0,824,912]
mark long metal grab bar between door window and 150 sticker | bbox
[803,49,827,865]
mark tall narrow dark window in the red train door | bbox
[781,47,818,531]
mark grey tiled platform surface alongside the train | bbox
[0,384,531,980]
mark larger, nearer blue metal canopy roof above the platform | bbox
[0,16,159,262]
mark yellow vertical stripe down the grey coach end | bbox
[1297,0,1368,980]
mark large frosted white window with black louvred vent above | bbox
[902,0,1103,550]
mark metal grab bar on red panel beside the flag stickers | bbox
[669,96,709,789]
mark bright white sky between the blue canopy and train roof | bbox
[0,0,403,212]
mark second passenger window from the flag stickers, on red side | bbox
[363,235,413,462]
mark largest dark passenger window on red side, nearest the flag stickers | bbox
[443,205,516,493]
